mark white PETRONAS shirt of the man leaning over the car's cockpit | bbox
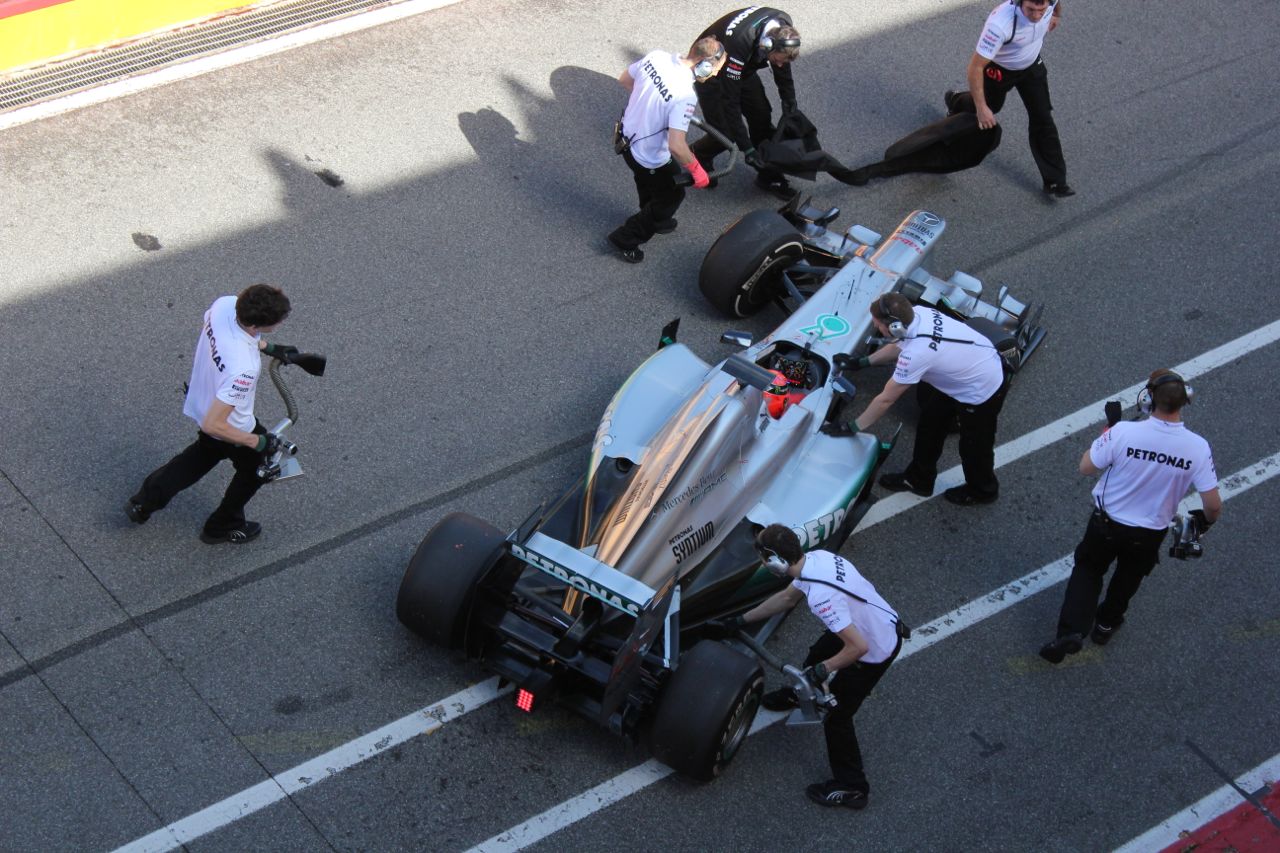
[893,305,1005,406]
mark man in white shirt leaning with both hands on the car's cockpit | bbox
[837,293,1009,506]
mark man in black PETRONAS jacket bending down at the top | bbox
[692,6,800,199]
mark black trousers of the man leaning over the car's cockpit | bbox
[906,373,1009,494]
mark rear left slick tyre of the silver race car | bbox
[396,512,503,649]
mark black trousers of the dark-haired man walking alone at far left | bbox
[132,424,266,537]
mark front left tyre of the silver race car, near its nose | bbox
[698,210,804,318]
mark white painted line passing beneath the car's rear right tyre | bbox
[467,452,1280,853]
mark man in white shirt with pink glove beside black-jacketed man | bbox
[609,38,724,264]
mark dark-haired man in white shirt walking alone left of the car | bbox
[124,284,297,544]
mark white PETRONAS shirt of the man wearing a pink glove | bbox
[622,50,698,169]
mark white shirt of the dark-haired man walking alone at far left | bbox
[182,296,262,433]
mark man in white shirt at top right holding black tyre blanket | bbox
[943,0,1075,199]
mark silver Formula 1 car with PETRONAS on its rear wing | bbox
[396,202,1042,780]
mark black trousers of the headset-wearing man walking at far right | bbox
[1057,512,1169,637]
